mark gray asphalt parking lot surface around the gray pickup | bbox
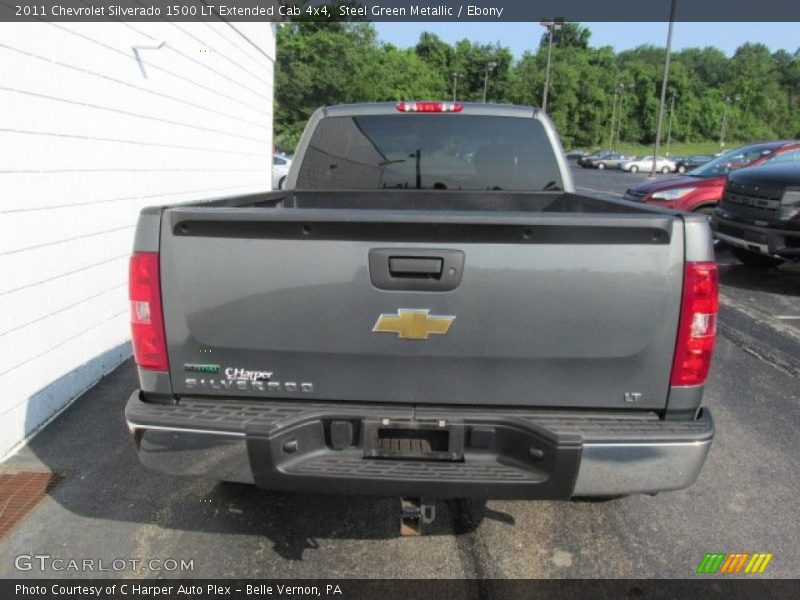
[0,169,800,578]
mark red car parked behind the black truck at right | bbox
[625,140,800,215]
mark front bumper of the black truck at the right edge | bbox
[711,209,800,260]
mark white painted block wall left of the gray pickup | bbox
[0,22,275,458]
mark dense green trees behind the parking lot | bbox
[275,22,800,151]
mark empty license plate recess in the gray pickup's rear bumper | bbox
[364,420,464,461]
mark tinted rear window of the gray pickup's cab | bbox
[296,114,563,191]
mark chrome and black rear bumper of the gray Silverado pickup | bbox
[125,391,714,499]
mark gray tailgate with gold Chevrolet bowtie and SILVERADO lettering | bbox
[160,206,684,409]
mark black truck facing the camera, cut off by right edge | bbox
[711,163,800,268]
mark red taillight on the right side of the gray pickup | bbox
[670,262,719,385]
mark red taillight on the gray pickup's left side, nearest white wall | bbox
[128,252,169,371]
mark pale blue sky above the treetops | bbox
[375,22,800,58]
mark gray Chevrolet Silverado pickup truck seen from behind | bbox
[126,102,717,499]
